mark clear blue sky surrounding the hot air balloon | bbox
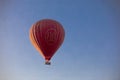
[0,0,120,80]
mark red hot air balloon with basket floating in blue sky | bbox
[29,19,65,65]
